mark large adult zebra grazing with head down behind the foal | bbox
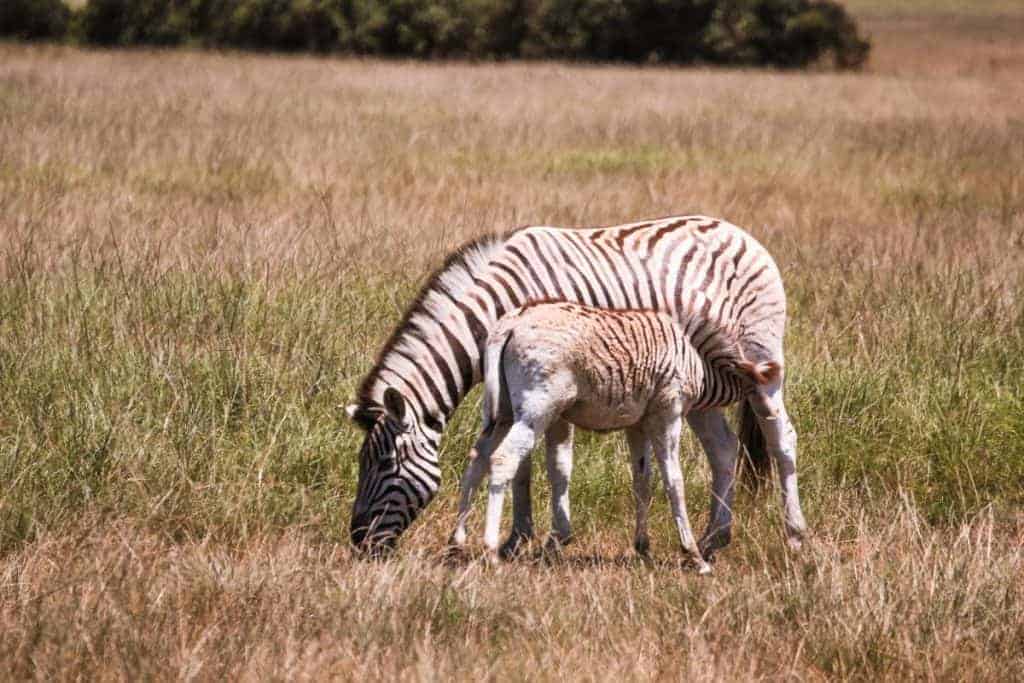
[348,216,805,555]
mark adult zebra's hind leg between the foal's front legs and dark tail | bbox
[686,409,739,560]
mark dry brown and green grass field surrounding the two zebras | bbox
[0,0,1024,680]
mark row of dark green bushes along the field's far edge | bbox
[8,0,869,69]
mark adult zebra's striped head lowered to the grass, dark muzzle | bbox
[347,387,440,555]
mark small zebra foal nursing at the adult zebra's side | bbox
[452,302,778,573]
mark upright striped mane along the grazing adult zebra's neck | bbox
[356,230,514,408]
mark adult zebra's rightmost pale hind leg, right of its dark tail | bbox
[749,386,807,550]
